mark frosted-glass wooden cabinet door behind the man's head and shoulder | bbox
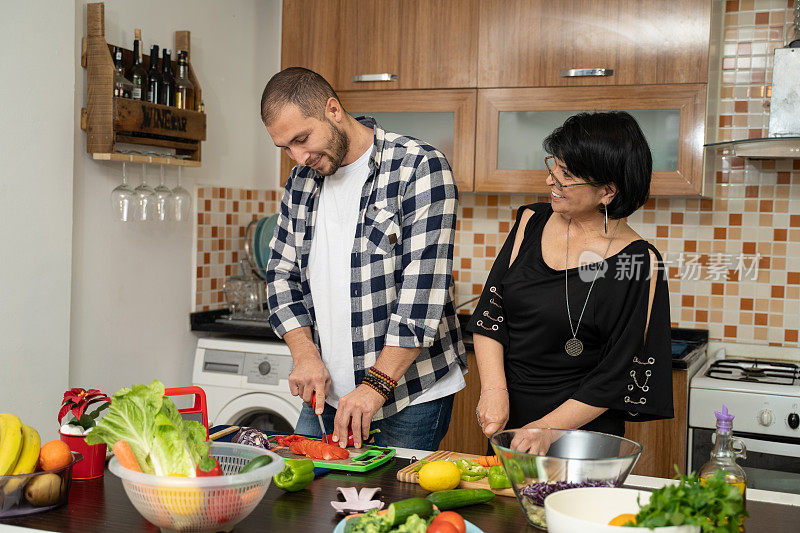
[281,89,477,192]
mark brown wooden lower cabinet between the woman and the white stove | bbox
[625,369,689,478]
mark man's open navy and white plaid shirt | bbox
[267,117,467,420]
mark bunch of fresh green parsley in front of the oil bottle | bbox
[636,470,747,533]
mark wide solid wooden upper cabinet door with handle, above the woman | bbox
[478,0,711,87]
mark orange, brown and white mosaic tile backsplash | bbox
[195,0,800,347]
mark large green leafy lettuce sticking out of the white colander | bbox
[86,380,208,477]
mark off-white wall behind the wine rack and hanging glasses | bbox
[70,0,280,393]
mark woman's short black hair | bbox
[542,111,653,219]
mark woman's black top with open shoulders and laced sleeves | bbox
[467,203,673,435]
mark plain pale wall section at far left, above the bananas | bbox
[0,0,75,440]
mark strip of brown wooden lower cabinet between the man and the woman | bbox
[439,351,489,455]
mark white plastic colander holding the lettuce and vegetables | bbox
[108,442,284,532]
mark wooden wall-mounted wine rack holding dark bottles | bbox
[81,2,206,167]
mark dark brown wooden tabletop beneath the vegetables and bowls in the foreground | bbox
[0,458,800,533]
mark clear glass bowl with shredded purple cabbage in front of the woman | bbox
[490,429,642,529]
